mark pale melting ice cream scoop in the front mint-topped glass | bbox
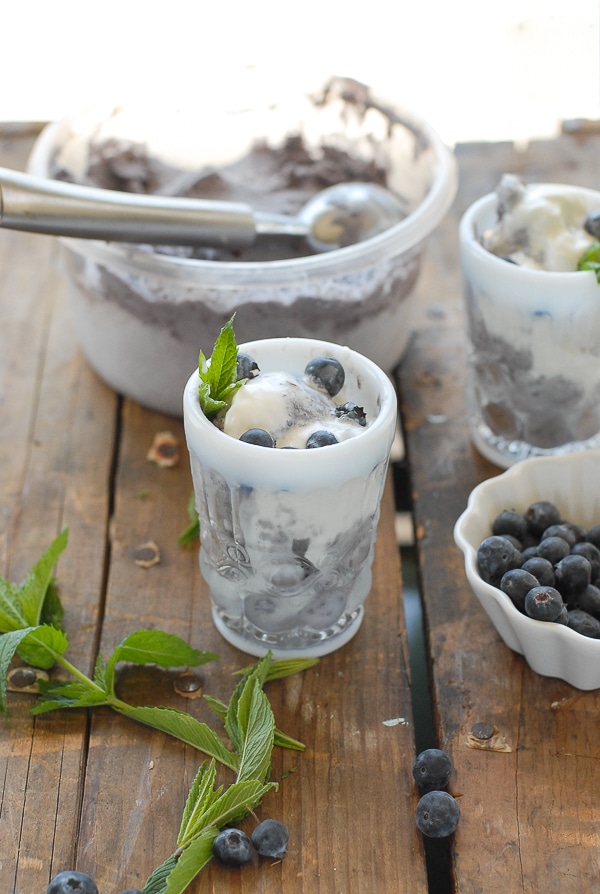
[223,372,362,448]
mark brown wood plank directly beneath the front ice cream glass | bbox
[79,403,426,894]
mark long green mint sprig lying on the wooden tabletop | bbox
[0,529,317,894]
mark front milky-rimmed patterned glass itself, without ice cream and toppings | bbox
[183,338,397,657]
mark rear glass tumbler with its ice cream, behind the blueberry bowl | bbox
[460,175,600,468]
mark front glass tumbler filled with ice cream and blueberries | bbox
[183,327,397,657]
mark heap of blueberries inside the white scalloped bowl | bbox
[477,500,600,639]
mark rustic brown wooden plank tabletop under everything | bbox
[0,126,600,894]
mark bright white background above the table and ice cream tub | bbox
[0,0,600,143]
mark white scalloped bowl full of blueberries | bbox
[454,450,600,690]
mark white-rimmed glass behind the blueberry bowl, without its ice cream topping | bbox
[460,184,600,468]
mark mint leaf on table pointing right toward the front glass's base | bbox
[106,630,219,691]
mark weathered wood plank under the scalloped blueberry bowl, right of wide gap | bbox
[399,137,600,894]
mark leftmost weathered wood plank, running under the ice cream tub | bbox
[0,130,116,894]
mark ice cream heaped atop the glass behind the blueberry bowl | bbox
[482,174,595,272]
